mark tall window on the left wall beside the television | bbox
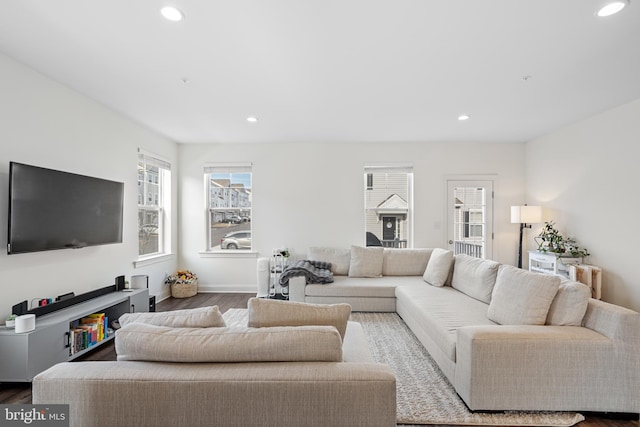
[138,150,171,257]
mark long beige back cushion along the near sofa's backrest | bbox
[115,323,342,363]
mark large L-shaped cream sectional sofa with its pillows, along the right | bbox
[278,247,640,413]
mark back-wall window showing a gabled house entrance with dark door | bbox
[364,165,413,248]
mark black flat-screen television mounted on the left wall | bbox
[7,162,124,254]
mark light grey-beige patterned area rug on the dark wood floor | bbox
[224,309,584,426]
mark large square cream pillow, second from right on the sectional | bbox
[487,265,560,325]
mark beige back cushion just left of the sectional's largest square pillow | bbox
[451,254,500,304]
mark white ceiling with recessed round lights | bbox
[0,0,640,142]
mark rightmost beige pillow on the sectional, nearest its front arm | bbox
[546,280,591,326]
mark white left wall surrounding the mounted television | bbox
[0,55,177,322]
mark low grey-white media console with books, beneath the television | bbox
[0,289,149,382]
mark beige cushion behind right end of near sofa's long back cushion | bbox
[247,298,351,339]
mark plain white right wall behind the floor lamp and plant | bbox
[526,100,640,310]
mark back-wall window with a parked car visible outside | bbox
[204,164,252,251]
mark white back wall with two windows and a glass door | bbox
[179,143,524,291]
